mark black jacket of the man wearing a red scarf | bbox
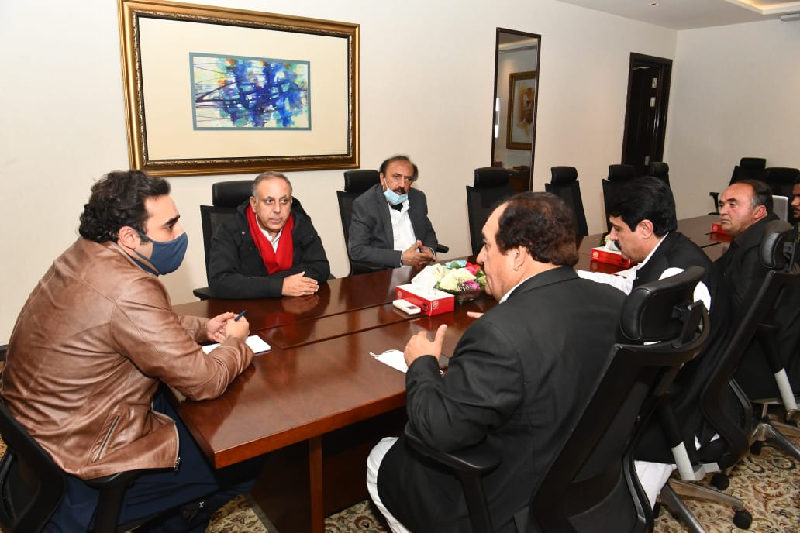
[208,198,331,299]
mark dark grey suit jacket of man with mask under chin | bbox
[347,184,438,268]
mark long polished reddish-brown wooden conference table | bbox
[169,216,724,533]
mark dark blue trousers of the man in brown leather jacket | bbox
[47,386,263,533]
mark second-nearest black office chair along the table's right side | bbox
[647,220,800,533]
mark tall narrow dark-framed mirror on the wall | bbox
[492,28,542,191]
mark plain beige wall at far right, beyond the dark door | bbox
[664,20,800,216]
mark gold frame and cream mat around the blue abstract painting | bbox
[118,0,359,176]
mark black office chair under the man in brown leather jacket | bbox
[0,401,158,533]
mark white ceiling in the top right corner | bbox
[558,0,800,30]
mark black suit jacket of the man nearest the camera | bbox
[378,267,625,532]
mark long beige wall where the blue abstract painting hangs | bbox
[0,0,680,338]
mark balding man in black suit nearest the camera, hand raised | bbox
[367,193,624,532]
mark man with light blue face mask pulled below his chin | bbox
[348,155,437,269]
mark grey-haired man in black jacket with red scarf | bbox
[208,172,330,299]
